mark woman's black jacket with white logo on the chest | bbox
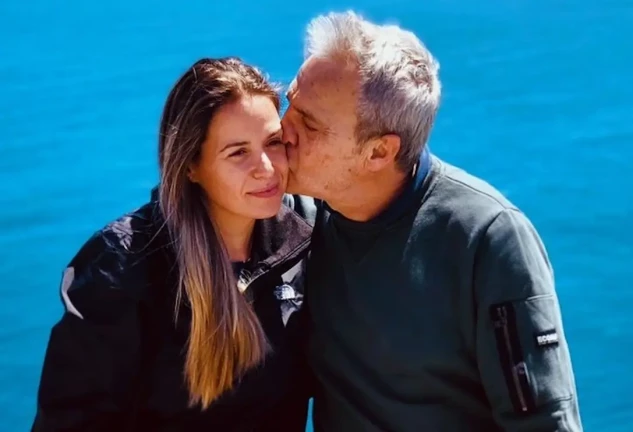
[32,194,312,432]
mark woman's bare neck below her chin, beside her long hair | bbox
[210,209,255,262]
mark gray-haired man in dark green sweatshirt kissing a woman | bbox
[283,13,582,432]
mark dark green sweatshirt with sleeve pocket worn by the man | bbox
[306,157,582,432]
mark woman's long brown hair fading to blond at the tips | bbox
[159,57,280,408]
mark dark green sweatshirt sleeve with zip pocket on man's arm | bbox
[474,209,582,432]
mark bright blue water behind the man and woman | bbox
[0,0,633,432]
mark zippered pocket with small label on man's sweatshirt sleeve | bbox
[490,295,572,413]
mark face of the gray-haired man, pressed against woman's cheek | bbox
[282,57,362,200]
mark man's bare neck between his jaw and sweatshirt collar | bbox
[327,169,411,222]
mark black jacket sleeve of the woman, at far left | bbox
[31,235,141,432]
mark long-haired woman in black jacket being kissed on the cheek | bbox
[33,58,311,432]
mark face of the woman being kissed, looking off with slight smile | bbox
[190,96,288,223]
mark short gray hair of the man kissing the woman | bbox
[305,12,441,170]
